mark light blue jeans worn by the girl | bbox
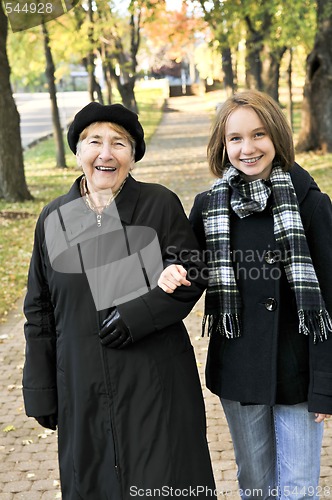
[221,399,324,500]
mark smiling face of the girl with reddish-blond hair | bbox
[225,106,276,182]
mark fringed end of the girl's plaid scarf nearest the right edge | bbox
[298,309,332,344]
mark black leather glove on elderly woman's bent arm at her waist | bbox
[99,308,133,349]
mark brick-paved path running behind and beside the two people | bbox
[0,96,332,500]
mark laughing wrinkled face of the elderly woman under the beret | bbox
[76,122,135,193]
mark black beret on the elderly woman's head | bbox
[67,102,145,161]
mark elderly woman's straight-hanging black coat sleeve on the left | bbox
[23,212,57,417]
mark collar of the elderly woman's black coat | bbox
[61,175,141,224]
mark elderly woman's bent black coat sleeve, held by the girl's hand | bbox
[117,189,207,341]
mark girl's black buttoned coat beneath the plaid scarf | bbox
[189,164,332,414]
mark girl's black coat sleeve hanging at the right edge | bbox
[306,194,332,414]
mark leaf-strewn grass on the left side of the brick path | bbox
[0,89,163,322]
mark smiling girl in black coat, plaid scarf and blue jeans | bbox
[159,90,332,499]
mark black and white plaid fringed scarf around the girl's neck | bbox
[203,165,332,342]
